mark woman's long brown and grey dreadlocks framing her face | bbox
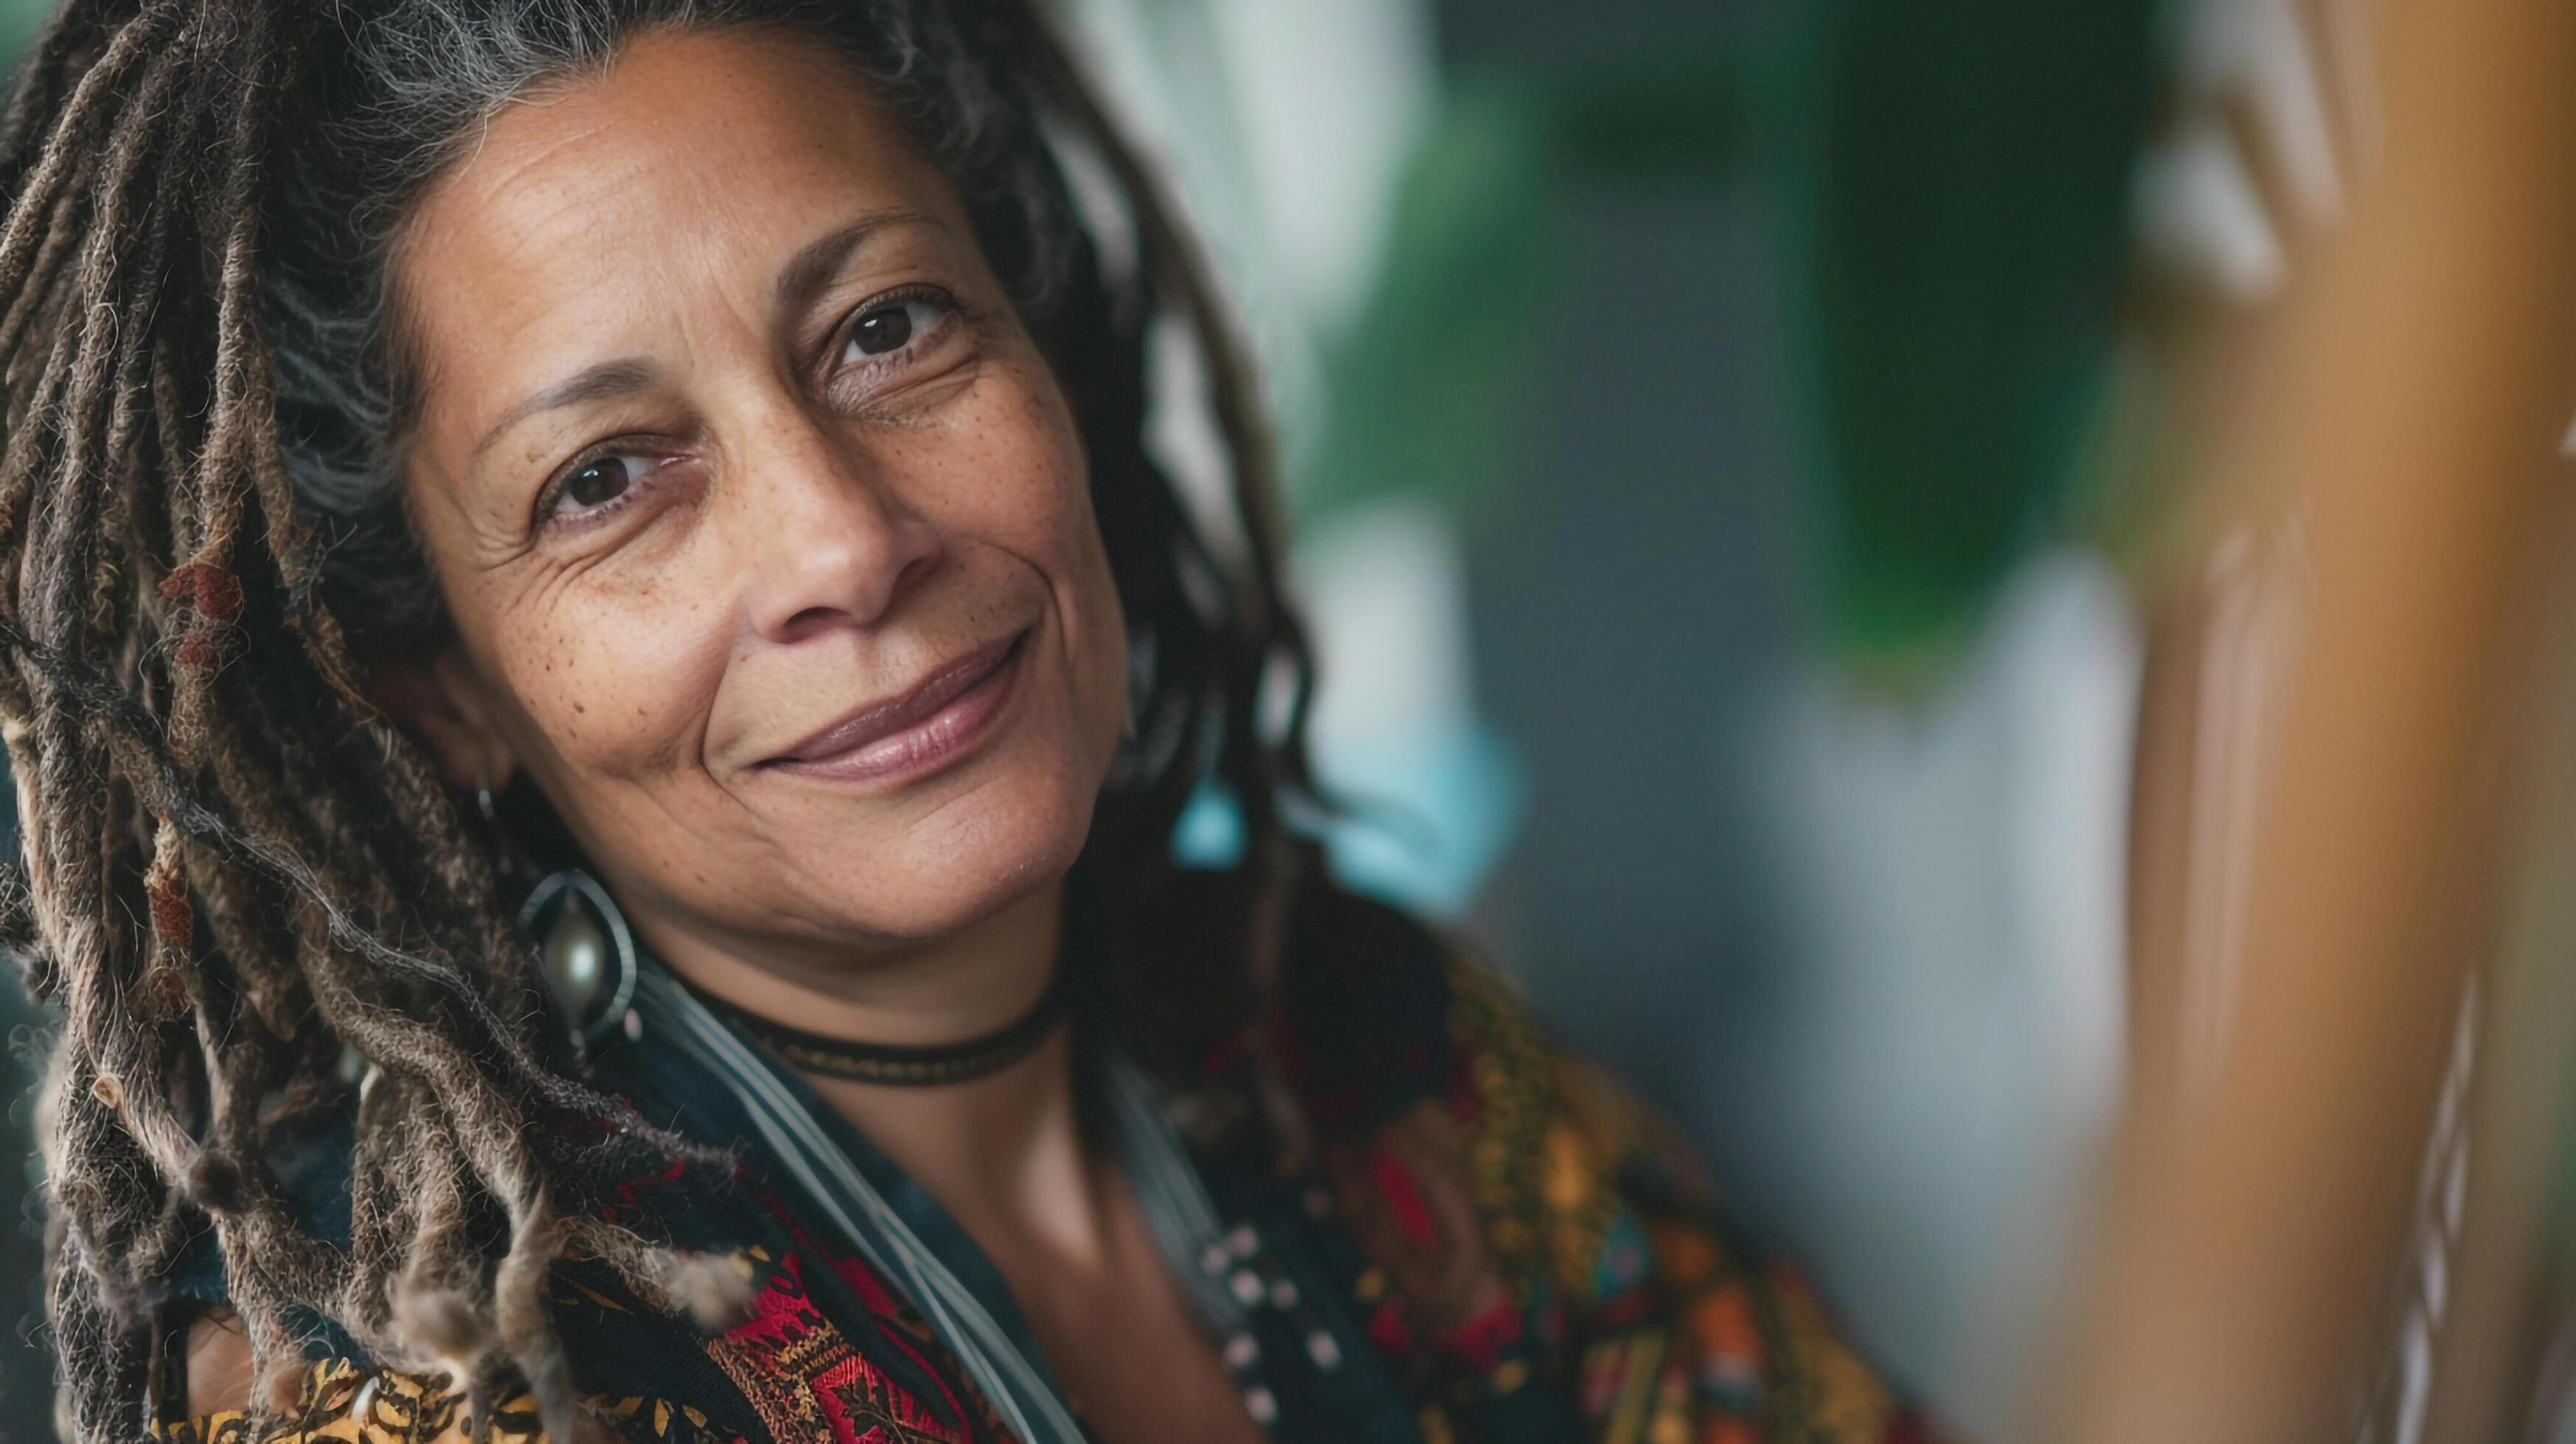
[0,0,1314,1442]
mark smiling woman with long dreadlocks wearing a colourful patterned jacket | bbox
[0,0,1911,1444]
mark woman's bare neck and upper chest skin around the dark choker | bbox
[637,883,1107,1264]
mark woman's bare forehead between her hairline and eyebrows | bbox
[394,31,968,455]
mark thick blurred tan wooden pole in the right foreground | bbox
[2035,0,2576,1444]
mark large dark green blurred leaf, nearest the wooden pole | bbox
[1780,0,2156,656]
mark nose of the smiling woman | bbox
[734,417,943,641]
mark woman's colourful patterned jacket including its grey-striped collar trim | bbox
[162,896,1930,1444]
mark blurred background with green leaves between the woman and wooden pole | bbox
[0,0,2576,1439]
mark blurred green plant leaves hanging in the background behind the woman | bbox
[1295,0,2156,672]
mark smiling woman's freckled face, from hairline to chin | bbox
[394,33,1126,958]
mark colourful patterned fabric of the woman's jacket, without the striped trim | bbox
[160,891,1930,1444]
